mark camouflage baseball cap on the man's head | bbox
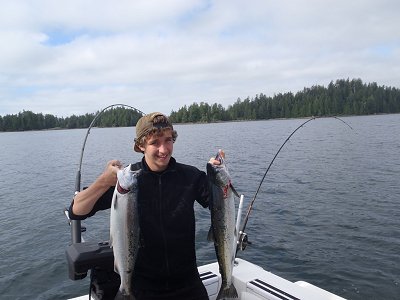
[134,112,174,152]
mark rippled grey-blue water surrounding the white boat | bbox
[0,115,400,299]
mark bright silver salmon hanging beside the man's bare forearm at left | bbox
[110,165,140,299]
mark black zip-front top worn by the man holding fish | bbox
[70,158,209,290]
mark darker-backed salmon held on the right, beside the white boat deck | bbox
[207,152,238,299]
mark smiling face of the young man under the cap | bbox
[139,129,174,172]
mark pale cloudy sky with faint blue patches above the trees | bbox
[0,0,400,117]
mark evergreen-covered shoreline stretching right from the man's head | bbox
[170,79,400,123]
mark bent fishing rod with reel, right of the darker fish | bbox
[236,116,353,253]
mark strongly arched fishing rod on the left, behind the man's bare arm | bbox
[67,103,145,243]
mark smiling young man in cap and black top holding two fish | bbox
[69,112,219,300]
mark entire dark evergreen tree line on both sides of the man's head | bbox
[0,79,400,131]
